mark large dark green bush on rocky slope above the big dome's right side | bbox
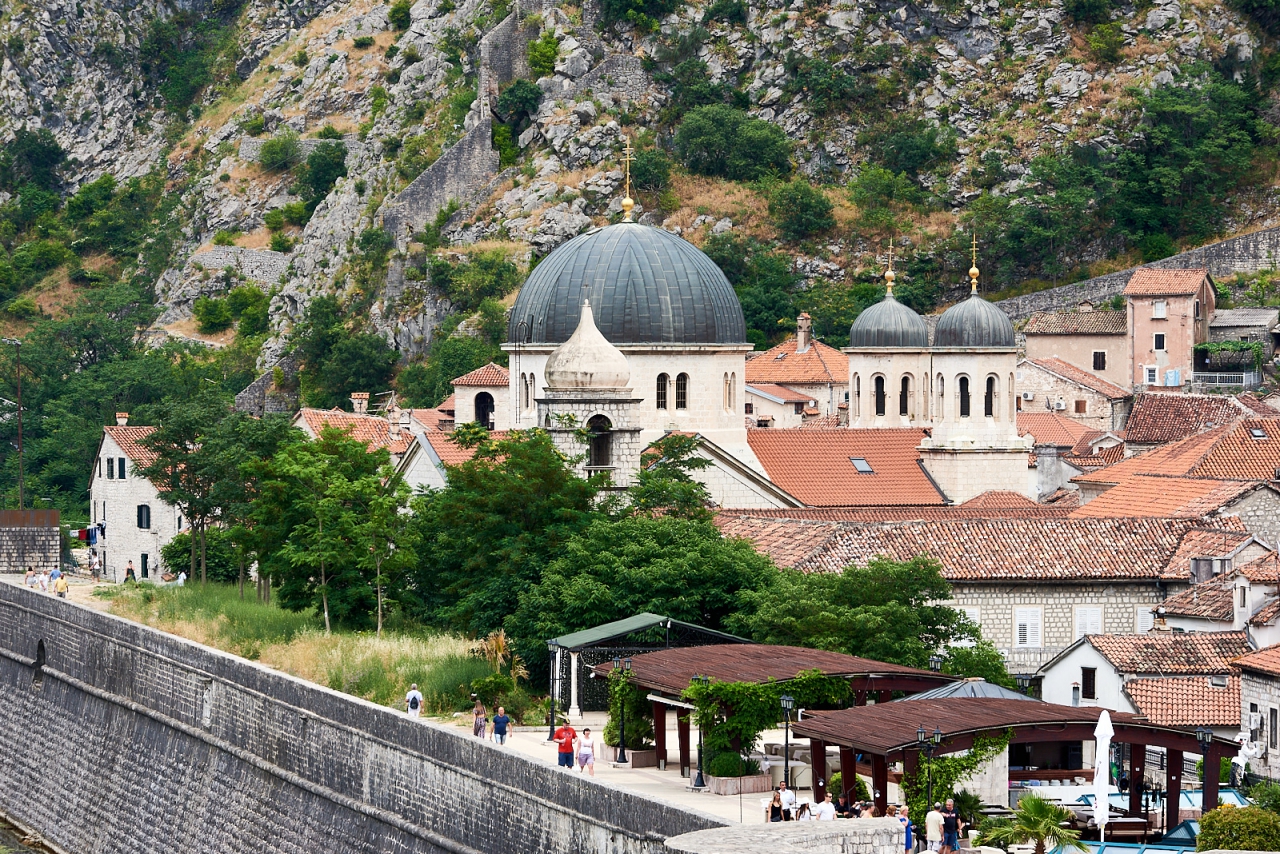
[676,104,791,181]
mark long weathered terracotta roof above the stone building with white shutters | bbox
[726,517,1223,581]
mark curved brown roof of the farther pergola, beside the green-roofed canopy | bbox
[595,644,956,696]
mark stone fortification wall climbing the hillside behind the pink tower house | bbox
[996,228,1280,320]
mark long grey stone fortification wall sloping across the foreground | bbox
[0,584,723,854]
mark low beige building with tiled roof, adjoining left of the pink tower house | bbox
[1023,303,1133,388]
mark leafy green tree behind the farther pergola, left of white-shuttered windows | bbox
[733,556,977,667]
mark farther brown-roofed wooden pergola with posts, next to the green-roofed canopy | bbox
[594,644,956,780]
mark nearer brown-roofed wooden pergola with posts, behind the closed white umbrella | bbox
[791,697,1236,827]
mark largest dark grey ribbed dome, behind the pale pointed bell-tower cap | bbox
[507,223,746,344]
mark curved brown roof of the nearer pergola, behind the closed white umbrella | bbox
[791,697,1226,755]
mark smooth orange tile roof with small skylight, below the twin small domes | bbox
[746,429,946,507]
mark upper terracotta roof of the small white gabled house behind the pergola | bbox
[1085,631,1249,676]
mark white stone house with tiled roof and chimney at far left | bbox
[88,412,187,581]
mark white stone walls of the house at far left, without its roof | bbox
[90,434,187,581]
